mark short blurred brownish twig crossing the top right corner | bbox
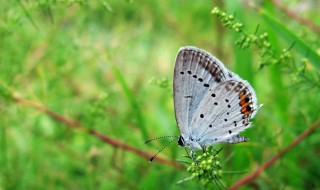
[271,0,320,33]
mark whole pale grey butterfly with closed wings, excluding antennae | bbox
[173,46,261,150]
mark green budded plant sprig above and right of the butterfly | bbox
[211,7,320,88]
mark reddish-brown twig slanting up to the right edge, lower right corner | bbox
[230,120,320,190]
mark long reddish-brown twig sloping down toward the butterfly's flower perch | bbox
[13,95,185,169]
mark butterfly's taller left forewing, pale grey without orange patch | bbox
[173,46,229,138]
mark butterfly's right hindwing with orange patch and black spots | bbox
[191,72,261,146]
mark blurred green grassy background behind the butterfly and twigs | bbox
[0,0,320,190]
